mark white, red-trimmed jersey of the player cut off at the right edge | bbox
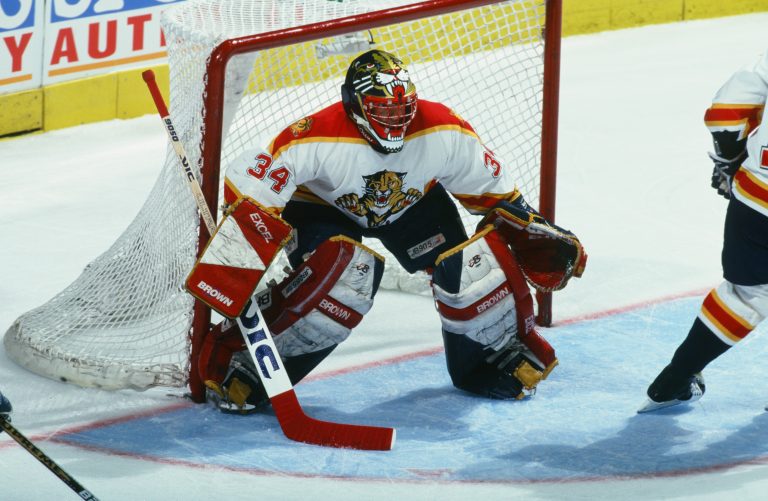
[704,52,768,216]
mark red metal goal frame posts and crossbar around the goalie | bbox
[189,0,562,402]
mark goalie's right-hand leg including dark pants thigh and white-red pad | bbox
[367,185,556,398]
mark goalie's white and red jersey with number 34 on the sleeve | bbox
[224,99,517,228]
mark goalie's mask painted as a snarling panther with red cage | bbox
[341,50,418,153]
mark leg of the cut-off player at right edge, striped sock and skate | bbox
[641,199,768,411]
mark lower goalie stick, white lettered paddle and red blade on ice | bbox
[237,301,396,451]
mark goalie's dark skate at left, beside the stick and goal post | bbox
[205,351,269,414]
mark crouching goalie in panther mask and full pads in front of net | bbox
[187,50,586,413]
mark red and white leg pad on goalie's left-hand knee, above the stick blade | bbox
[257,236,384,357]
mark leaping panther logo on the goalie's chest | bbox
[336,170,422,228]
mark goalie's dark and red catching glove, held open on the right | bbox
[478,193,587,292]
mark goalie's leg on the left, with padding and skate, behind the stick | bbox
[199,202,383,412]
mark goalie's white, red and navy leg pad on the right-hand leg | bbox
[432,226,557,398]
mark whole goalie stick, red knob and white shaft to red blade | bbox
[142,70,395,451]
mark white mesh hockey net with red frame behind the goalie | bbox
[5,0,560,400]
